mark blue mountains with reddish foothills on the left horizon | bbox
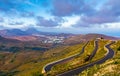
[0,28,73,41]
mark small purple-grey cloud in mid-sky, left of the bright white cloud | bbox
[37,16,64,27]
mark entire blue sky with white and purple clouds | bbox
[0,0,120,36]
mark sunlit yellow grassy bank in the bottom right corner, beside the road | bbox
[79,41,120,76]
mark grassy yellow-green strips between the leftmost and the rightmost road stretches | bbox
[48,40,108,75]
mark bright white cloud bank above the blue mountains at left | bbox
[0,17,36,28]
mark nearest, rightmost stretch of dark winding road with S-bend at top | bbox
[57,41,115,76]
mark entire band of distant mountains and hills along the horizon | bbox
[0,28,118,44]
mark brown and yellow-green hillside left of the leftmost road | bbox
[0,43,84,76]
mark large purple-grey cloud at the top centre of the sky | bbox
[51,0,96,17]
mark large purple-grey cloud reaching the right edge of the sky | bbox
[75,0,120,27]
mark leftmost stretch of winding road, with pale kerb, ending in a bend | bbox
[42,41,89,73]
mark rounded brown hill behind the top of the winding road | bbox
[64,33,118,44]
